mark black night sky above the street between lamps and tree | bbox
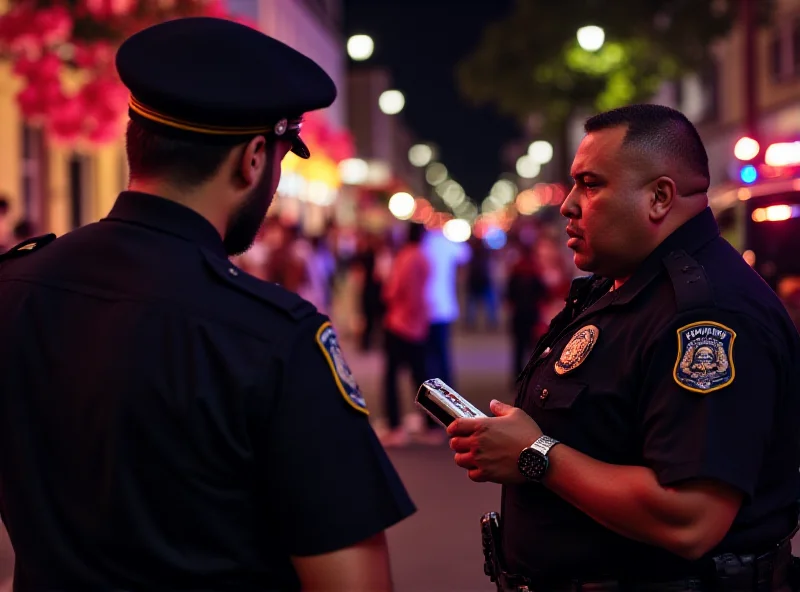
[344,0,519,203]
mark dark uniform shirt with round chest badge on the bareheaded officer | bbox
[503,209,800,581]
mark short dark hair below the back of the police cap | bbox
[125,120,238,187]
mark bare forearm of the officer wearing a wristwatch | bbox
[544,444,735,559]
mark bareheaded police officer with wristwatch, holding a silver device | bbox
[449,105,800,591]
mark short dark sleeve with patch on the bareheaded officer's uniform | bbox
[641,310,781,497]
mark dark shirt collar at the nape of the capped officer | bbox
[105,191,228,258]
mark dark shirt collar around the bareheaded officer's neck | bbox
[613,208,719,304]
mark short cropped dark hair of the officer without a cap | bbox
[584,105,711,189]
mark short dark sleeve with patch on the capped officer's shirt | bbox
[258,320,415,556]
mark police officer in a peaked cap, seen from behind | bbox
[0,18,414,592]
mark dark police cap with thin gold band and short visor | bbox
[116,17,336,158]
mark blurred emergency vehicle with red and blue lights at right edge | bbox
[709,137,800,327]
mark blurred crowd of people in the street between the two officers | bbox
[235,217,577,446]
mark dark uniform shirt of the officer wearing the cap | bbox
[0,193,414,591]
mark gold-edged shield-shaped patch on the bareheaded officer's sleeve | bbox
[672,321,736,394]
